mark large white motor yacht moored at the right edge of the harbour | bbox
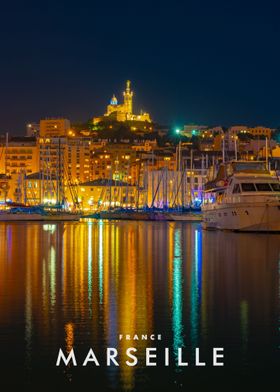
[202,161,280,232]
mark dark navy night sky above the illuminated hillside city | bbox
[0,0,280,134]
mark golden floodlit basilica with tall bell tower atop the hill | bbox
[93,80,152,125]
